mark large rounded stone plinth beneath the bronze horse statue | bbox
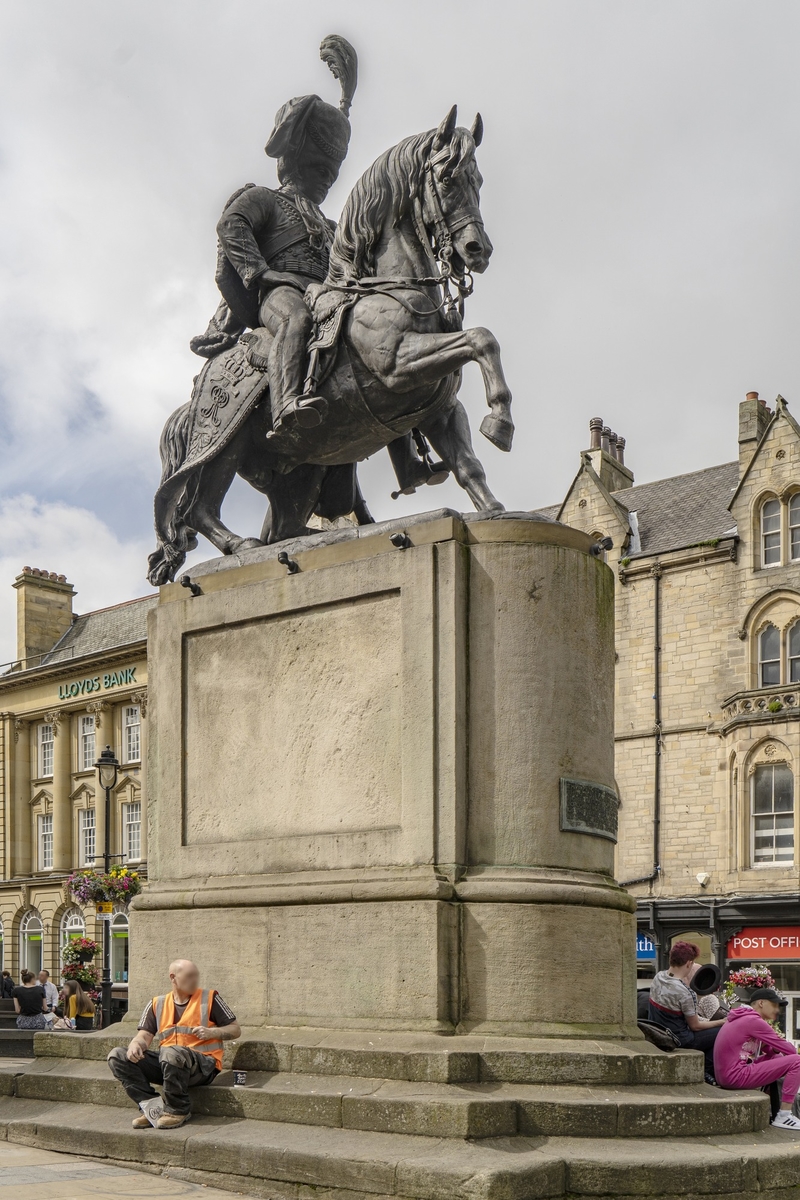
[131,510,638,1037]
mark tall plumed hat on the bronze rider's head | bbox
[264,34,359,163]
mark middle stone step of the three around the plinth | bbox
[0,1058,769,1138]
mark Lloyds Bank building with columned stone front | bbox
[0,566,156,1007]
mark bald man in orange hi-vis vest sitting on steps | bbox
[108,959,241,1129]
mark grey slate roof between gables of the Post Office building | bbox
[612,462,739,558]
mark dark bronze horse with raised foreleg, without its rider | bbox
[149,107,513,584]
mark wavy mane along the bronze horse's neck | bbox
[327,128,475,284]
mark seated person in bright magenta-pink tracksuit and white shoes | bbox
[714,988,800,1129]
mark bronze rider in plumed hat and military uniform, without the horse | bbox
[190,35,447,494]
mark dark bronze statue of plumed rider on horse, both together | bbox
[149,37,513,584]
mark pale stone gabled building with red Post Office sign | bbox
[546,392,800,1040]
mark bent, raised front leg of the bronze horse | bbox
[387,325,513,450]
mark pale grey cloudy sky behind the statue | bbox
[0,0,800,659]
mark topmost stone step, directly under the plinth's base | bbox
[35,1025,704,1086]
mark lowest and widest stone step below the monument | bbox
[0,1098,800,1200]
